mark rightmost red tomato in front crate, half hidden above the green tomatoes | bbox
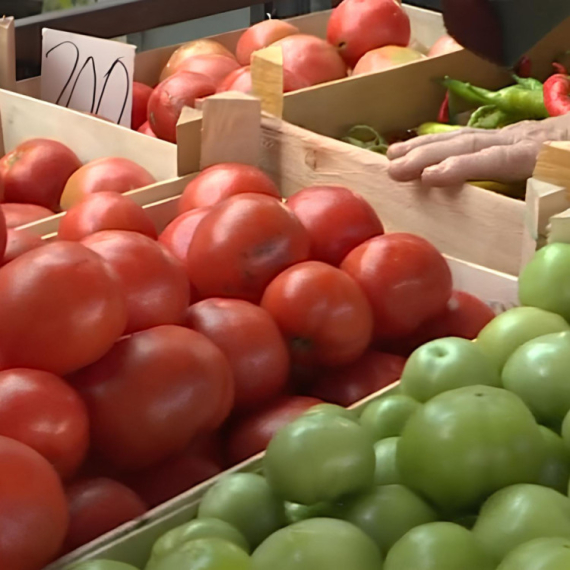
[383,291,495,356]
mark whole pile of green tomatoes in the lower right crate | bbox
[74,244,570,570]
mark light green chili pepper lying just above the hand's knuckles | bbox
[443,77,549,119]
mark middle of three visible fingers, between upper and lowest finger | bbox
[388,131,511,182]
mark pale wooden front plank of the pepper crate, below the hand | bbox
[261,117,525,275]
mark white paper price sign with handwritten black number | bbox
[42,28,136,127]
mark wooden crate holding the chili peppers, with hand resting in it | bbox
[248,19,570,275]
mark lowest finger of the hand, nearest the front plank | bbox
[422,140,541,187]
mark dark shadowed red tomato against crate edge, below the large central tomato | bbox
[121,438,222,507]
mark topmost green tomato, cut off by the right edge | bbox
[519,243,570,321]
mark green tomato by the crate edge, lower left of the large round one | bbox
[198,473,286,548]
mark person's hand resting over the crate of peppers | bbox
[387,114,570,187]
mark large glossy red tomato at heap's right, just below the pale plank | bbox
[341,233,452,339]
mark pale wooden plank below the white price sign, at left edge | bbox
[0,90,177,180]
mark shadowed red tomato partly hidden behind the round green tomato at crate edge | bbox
[226,396,323,465]
